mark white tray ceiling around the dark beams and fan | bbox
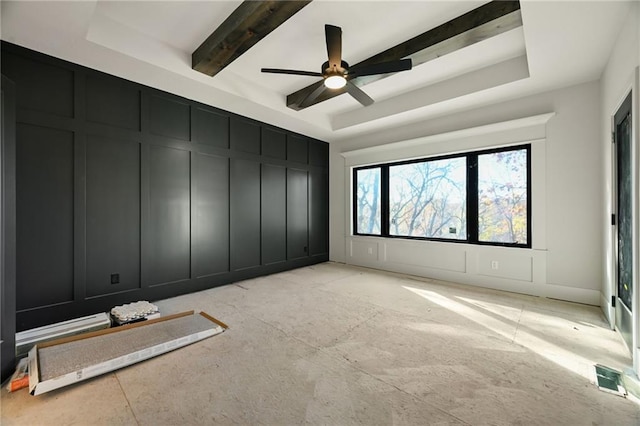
[0,0,629,142]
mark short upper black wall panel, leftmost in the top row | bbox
[2,52,74,117]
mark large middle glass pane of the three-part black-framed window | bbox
[389,157,467,240]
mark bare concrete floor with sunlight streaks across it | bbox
[0,263,640,426]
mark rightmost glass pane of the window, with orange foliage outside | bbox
[478,149,528,244]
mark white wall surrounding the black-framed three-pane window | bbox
[330,82,604,305]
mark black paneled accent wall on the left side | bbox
[2,42,329,331]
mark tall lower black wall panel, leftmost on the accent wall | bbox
[16,124,74,310]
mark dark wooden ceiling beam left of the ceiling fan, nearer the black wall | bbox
[191,0,311,76]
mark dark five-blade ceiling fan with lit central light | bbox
[262,25,411,108]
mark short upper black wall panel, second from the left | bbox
[86,74,140,131]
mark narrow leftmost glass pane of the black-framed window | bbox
[355,167,382,235]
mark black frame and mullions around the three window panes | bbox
[351,143,533,248]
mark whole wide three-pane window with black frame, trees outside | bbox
[353,145,531,247]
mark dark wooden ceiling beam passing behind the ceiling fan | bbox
[287,0,522,111]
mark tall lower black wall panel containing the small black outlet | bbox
[86,136,140,296]
